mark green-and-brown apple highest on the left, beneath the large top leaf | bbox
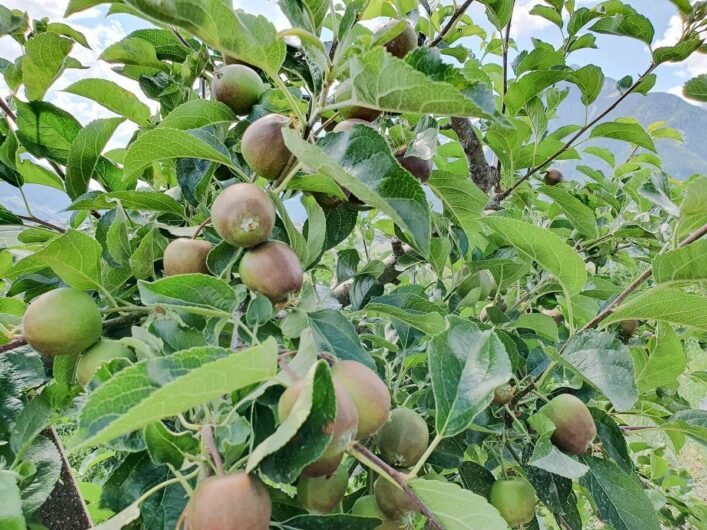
[211,64,267,116]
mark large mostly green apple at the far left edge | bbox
[22,287,103,356]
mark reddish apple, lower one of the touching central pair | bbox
[238,241,304,302]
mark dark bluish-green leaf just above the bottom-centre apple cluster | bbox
[307,309,375,368]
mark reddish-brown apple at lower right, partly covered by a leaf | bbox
[540,394,597,455]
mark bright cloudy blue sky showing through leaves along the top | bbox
[0,0,707,219]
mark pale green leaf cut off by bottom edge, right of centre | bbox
[410,479,508,530]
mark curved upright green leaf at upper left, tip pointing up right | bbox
[65,118,123,199]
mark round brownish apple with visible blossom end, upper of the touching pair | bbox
[211,182,275,247]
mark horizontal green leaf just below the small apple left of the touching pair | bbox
[138,274,238,318]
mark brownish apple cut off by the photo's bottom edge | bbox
[186,471,272,530]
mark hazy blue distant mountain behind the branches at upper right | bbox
[551,79,707,180]
